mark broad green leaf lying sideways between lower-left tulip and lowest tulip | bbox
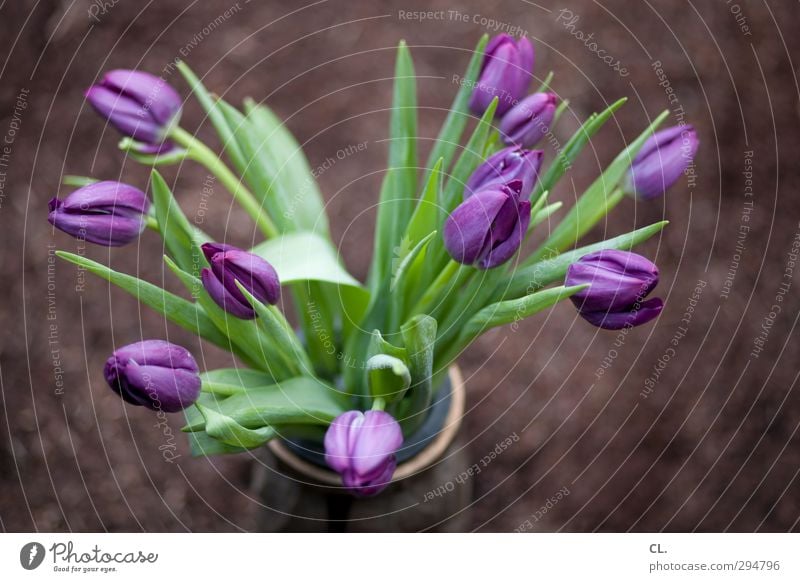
[183,376,348,432]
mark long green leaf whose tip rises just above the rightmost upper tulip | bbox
[526,111,669,264]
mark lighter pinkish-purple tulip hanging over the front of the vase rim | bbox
[325,410,403,497]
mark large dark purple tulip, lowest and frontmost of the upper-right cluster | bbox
[444,180,531,269]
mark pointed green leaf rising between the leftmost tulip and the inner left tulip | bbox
[150,170,210,275]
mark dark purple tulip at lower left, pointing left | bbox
[103,340,201,412]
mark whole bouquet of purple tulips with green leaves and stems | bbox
[49,35,698,496]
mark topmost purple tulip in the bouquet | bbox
[469,34,533,117]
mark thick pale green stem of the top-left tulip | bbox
[170,127,280,238]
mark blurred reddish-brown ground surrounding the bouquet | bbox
[0,0,800,531]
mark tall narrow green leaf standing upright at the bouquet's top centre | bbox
[368,41,417,294]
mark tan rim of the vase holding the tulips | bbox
[267,364,466,487]
